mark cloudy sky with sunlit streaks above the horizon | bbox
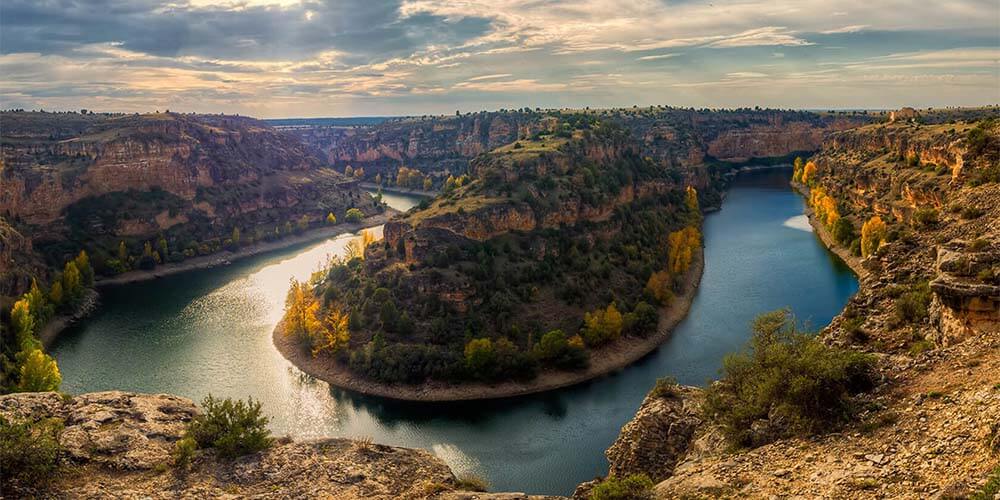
[0,0,1000,118]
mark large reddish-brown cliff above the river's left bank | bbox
[0,112,378,293]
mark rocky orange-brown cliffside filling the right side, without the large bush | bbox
[578,113,1000,498]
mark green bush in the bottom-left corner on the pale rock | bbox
[0,416,63,493]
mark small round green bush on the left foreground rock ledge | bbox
[188,395,273,458]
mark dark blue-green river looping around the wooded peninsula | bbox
[51,170,858,495]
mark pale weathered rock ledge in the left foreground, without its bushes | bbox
[0,391,560,500]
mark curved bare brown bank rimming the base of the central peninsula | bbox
[272,248,705,402]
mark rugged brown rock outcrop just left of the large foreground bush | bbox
[604,387,702,482]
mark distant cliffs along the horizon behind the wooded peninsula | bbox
[289,107,874,180]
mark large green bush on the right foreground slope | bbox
[706,310,873,446]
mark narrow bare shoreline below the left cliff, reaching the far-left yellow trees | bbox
[38,211,399,349]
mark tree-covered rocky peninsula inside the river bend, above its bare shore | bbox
[285,120,714,384]
